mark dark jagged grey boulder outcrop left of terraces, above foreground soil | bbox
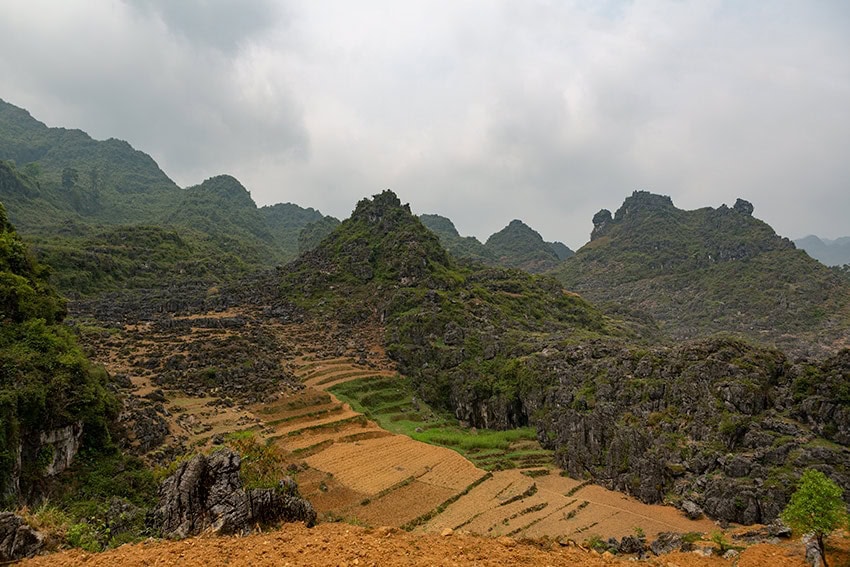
[151,449,316,539]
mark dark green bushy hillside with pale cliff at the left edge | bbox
[0,204,117,505]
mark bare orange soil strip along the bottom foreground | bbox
[21,524,816,567]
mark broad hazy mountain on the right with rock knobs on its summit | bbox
[552,191,850,352]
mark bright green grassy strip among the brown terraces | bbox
[330,376,552,470]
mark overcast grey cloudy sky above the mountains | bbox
[0,0,850,249]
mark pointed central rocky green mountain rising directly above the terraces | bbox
[280,191,616,422]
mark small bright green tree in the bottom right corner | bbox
[781,469,847,567]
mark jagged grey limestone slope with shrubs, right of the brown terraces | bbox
[533,339,850,524]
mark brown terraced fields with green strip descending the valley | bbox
[81,312,716,541]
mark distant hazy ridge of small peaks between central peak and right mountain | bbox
[419,215,573,273]
